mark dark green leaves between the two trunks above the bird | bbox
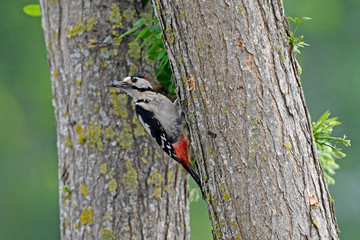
[114,17,175,94]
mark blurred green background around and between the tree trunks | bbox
[0,0,360,240]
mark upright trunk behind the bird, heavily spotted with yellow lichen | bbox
[40,0,189,239]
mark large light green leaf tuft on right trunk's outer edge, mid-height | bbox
[312,111,350,184]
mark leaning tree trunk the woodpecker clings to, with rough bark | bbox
[153,0,339,239]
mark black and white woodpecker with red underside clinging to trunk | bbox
[108,75,201,189]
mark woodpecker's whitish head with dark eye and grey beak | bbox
[108,75,152,91]
